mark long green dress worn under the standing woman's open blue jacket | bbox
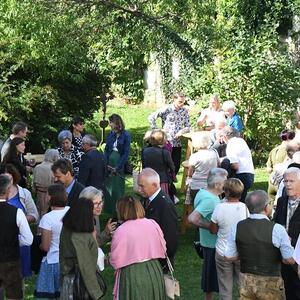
[104,151,125,216]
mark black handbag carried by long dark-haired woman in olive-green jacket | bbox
[73,266,107,300]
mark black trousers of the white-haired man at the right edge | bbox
[281,264,300,300]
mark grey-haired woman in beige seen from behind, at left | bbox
[33,149,59,217]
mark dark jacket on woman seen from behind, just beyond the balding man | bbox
[142,146,175,183]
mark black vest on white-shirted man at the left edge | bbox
[0,202,20,263]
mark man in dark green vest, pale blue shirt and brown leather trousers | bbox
[225,190,294,300]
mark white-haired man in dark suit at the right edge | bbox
[274,167,300,300]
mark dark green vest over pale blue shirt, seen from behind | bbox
[236,218,281,276]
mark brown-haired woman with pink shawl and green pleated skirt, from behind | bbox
[110,196,166,300]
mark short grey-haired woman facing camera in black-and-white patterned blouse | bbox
[57,130,83,178]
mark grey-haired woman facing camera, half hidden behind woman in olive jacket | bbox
[79,186,117,247]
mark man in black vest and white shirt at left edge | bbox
[0,174,33,300]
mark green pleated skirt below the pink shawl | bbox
[119,259,167,300]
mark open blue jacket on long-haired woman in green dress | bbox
[104,130,131,171]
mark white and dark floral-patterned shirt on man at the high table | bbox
[148,104,190,147]
